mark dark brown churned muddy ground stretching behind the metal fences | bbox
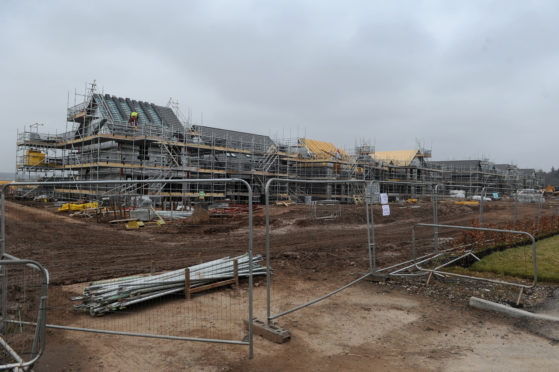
[6,202,557,284]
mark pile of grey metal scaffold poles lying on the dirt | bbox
[72,254,266,316]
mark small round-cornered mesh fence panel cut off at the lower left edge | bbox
[0,257,48,370]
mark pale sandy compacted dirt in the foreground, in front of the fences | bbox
[36,282,559,371]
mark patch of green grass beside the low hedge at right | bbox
[466,235,559,283]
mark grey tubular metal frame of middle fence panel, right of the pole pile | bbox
[265,178,374,325]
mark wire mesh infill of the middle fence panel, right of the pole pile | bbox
[266,180,369,319]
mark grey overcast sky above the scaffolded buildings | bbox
[0,0,559,171]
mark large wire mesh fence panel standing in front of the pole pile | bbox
[1,178,256,358]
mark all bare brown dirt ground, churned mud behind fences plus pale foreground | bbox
[6,202,559,371]
